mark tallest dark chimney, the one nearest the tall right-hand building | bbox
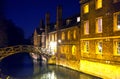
[56,6,62,30]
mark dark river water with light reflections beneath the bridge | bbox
[0,53,101,79]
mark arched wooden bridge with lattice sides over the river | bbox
[0,45,51,60]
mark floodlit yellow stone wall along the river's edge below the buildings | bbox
[48,59,120,79]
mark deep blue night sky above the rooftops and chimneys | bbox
[4,0,80,38]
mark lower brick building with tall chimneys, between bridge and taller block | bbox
[46,6,80,64]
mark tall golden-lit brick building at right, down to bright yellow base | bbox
[80,0,120,79]
